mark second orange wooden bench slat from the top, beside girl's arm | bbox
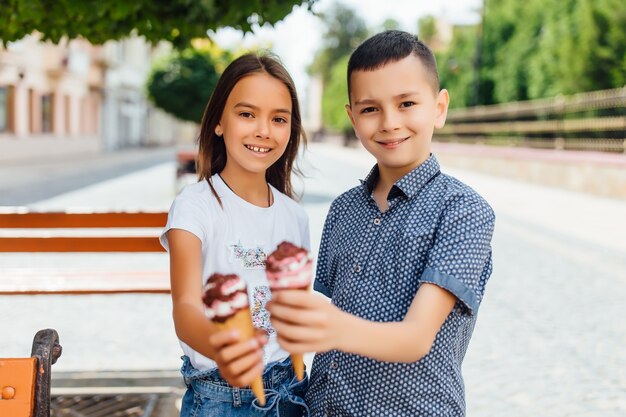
[0,236,165,252]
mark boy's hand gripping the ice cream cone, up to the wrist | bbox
[267,290,345,353]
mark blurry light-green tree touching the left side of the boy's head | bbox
[322,56,352,134]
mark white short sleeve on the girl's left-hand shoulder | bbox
[159,190,209,251]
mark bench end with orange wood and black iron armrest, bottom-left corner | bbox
[0,329,62,417]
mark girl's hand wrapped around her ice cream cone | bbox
[209,329,267,388]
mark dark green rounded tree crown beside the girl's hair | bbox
[148,48,224,123]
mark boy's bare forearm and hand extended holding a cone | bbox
[268,283,456,363]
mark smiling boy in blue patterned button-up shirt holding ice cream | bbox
[270,31,494,417]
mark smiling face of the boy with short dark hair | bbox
[346,54,448,176]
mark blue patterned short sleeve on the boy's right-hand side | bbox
[420,197,495,314]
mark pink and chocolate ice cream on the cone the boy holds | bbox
[265,242,313,290]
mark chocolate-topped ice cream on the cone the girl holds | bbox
[202,273,248,322]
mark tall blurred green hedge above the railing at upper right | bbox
[438,0,626,107]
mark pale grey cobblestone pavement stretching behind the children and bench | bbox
[0,144,626,417]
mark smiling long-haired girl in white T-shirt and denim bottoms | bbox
[161,54,310,417]
